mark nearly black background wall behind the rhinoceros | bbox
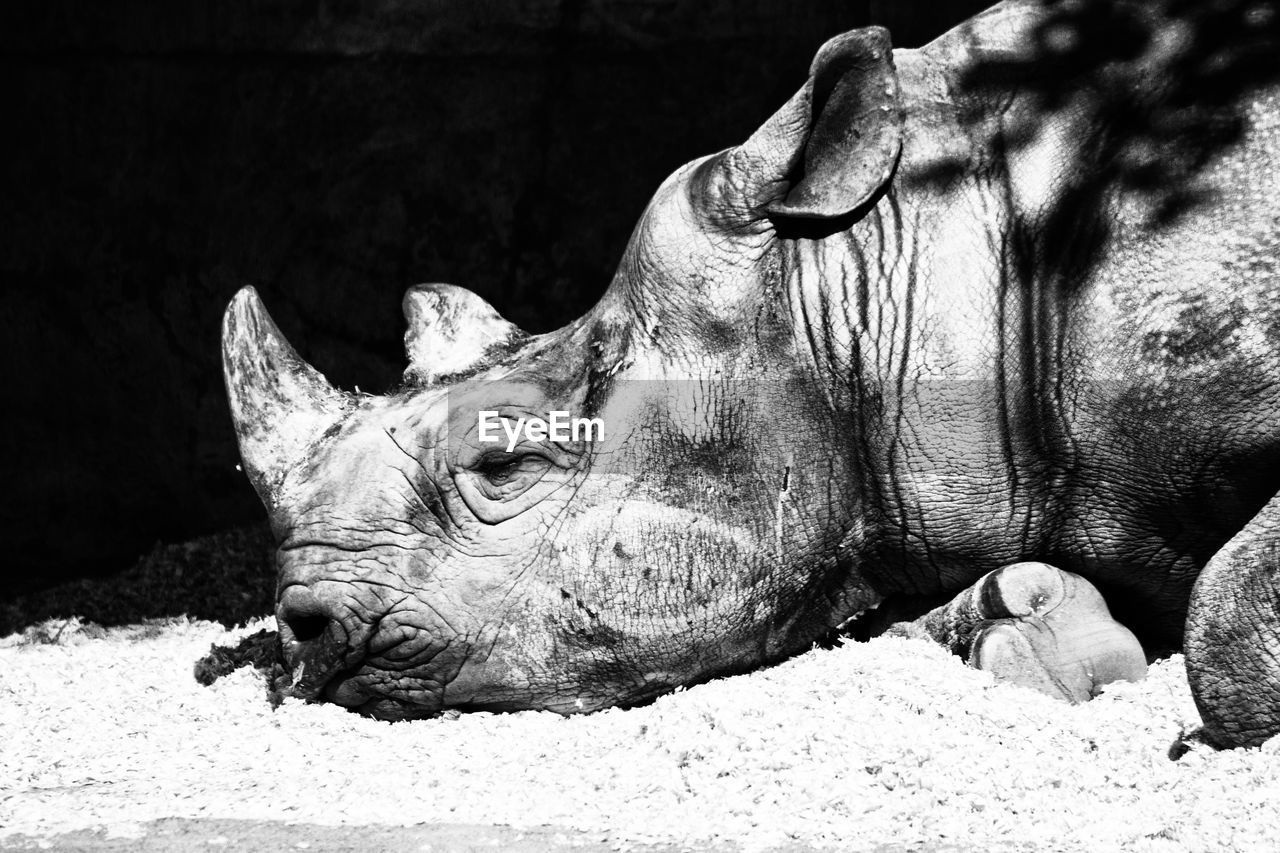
[0,0,986,599]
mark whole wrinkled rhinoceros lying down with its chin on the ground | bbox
[223,1,1280,744]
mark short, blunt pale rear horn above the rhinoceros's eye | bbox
[403,284,529,384]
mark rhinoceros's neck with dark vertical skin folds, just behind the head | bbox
[783,176,1090,593]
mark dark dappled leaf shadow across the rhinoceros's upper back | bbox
[932,0,1280,287]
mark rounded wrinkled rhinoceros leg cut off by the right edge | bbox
[1185,494,1280,747]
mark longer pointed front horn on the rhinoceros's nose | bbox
[223,287,351,508]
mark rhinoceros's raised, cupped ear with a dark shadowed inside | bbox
[723,27,904,219]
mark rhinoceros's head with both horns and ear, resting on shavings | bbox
[223,29,901,719]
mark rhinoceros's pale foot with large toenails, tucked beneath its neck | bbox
[895,562,1147,702]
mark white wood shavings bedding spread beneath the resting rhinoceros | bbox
[0,620,1280,850]
